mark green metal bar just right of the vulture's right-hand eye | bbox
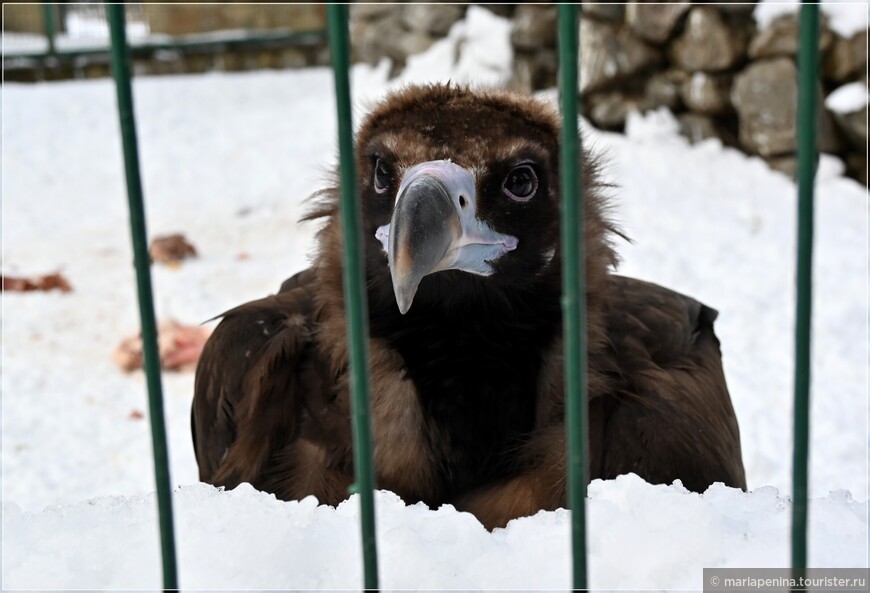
[558,4,588,589]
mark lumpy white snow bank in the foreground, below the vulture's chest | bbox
[3,475,867,590]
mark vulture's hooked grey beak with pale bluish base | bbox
[375,161,518,315]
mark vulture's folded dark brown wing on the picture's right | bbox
[600,276,746,492]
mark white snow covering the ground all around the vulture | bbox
[2,5,868,589]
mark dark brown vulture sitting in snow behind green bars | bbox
[191,84,746,529]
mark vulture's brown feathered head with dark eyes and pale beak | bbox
[311,85,615,323]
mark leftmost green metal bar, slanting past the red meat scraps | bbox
[106,4,178,590]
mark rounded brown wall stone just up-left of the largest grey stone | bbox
[671,6,747,72]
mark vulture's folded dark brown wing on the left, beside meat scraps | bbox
[191,272,313,488]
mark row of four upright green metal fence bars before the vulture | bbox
[108,3,819,590]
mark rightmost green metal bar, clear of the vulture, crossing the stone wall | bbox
[791,2,819,577]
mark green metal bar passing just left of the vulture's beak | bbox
[327,4,378,590]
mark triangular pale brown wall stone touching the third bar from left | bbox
[579,18,660,94]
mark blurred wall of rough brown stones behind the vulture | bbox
[351,2,867,184]
